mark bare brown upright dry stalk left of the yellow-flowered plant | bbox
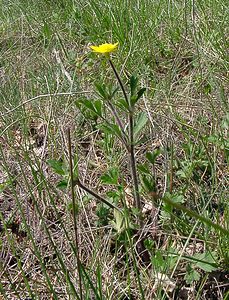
[67,128,83,300]
